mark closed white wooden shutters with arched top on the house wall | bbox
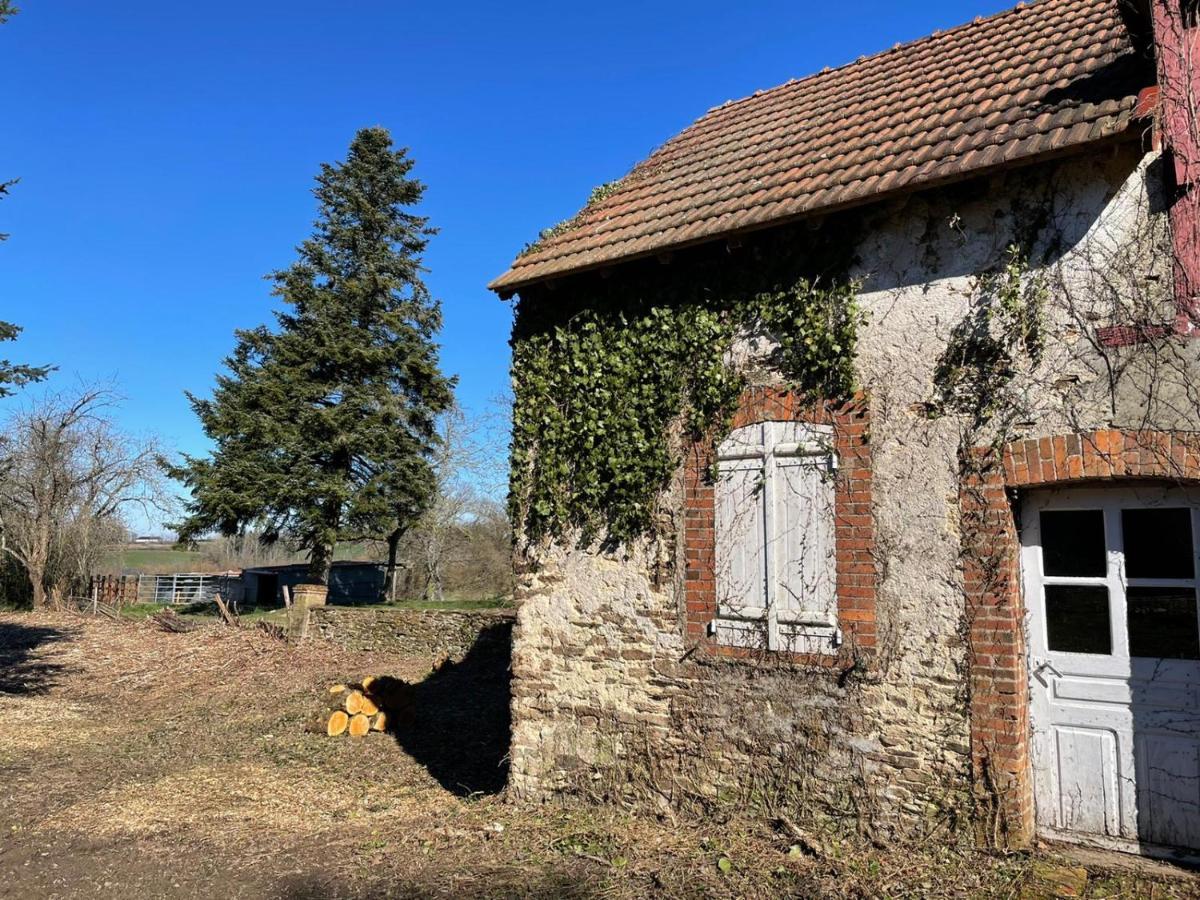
[710,421,838,653]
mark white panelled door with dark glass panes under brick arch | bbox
[1021,486,1200,853]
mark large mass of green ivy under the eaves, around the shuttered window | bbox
[509,229,862,542]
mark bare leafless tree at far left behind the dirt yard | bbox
[0,389,166,608]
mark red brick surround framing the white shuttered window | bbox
[684,388,876,665]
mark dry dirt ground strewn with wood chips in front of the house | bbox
[0,613,1200,899]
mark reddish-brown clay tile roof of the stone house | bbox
[490,0,1147,293]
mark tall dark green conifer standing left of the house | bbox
[168,128,454,583]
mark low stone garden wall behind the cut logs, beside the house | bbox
[308,606,515,660]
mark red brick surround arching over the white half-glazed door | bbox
[960,430,1200,847]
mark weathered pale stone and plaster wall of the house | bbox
[510,145,1200,838]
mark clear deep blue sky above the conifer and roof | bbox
[0,0,1009,528]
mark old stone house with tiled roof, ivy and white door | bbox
[491,0,1200,853]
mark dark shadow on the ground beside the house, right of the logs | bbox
[389,623,511,797]
